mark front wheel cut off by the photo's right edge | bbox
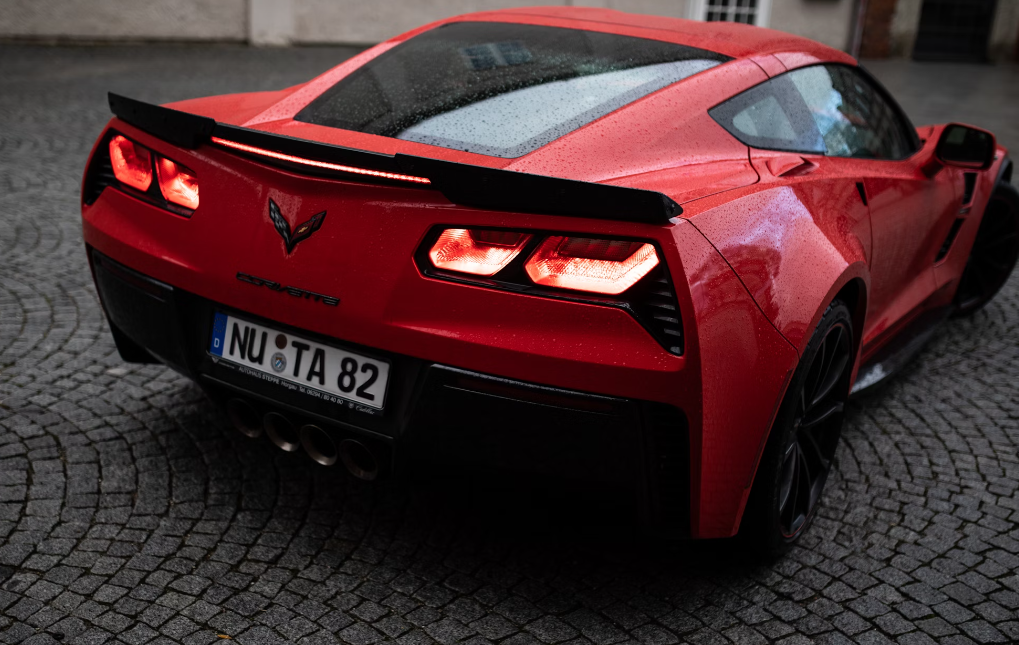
[954,182,1019,317]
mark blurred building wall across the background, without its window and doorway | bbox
[0,0,1019,59]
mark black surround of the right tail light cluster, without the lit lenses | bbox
[414,224,685,356]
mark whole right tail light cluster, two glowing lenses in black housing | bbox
[415,226,684,356]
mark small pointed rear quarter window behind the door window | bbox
[708,74,824,154]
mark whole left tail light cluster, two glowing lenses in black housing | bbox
[82,130,198,217]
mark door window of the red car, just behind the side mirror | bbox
[785,65,913,159]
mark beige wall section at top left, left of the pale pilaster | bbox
[0,0,248,41]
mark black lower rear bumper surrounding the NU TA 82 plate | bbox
[89,248,690,536]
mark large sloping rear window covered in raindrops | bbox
[294,22,730,158]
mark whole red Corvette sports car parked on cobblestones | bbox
[82,8,1019,552]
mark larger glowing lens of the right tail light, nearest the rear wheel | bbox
[524,235,658,295]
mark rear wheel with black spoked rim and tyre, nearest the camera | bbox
[740,301,855,558]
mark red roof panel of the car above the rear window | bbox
[434,6,856,66]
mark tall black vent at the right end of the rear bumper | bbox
[643,402,690,537]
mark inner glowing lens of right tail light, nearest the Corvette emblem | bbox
[428,228,531,275]
